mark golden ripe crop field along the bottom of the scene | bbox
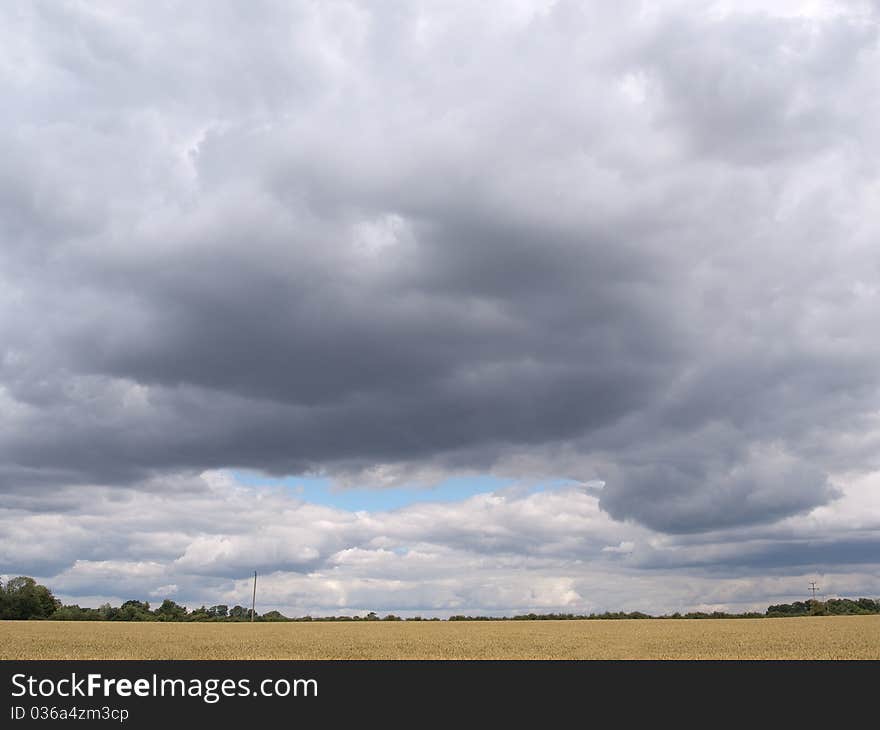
[0,616,880,659]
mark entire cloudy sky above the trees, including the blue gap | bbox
[0,0,880,616]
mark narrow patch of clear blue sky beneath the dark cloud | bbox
[231,471,572,512]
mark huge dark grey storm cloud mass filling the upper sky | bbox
[0,2,880,533]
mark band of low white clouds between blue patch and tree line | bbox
[0,472,880,616]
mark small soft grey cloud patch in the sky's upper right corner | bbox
[646,14,877,165]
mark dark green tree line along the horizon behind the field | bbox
[0,575,880,622]
